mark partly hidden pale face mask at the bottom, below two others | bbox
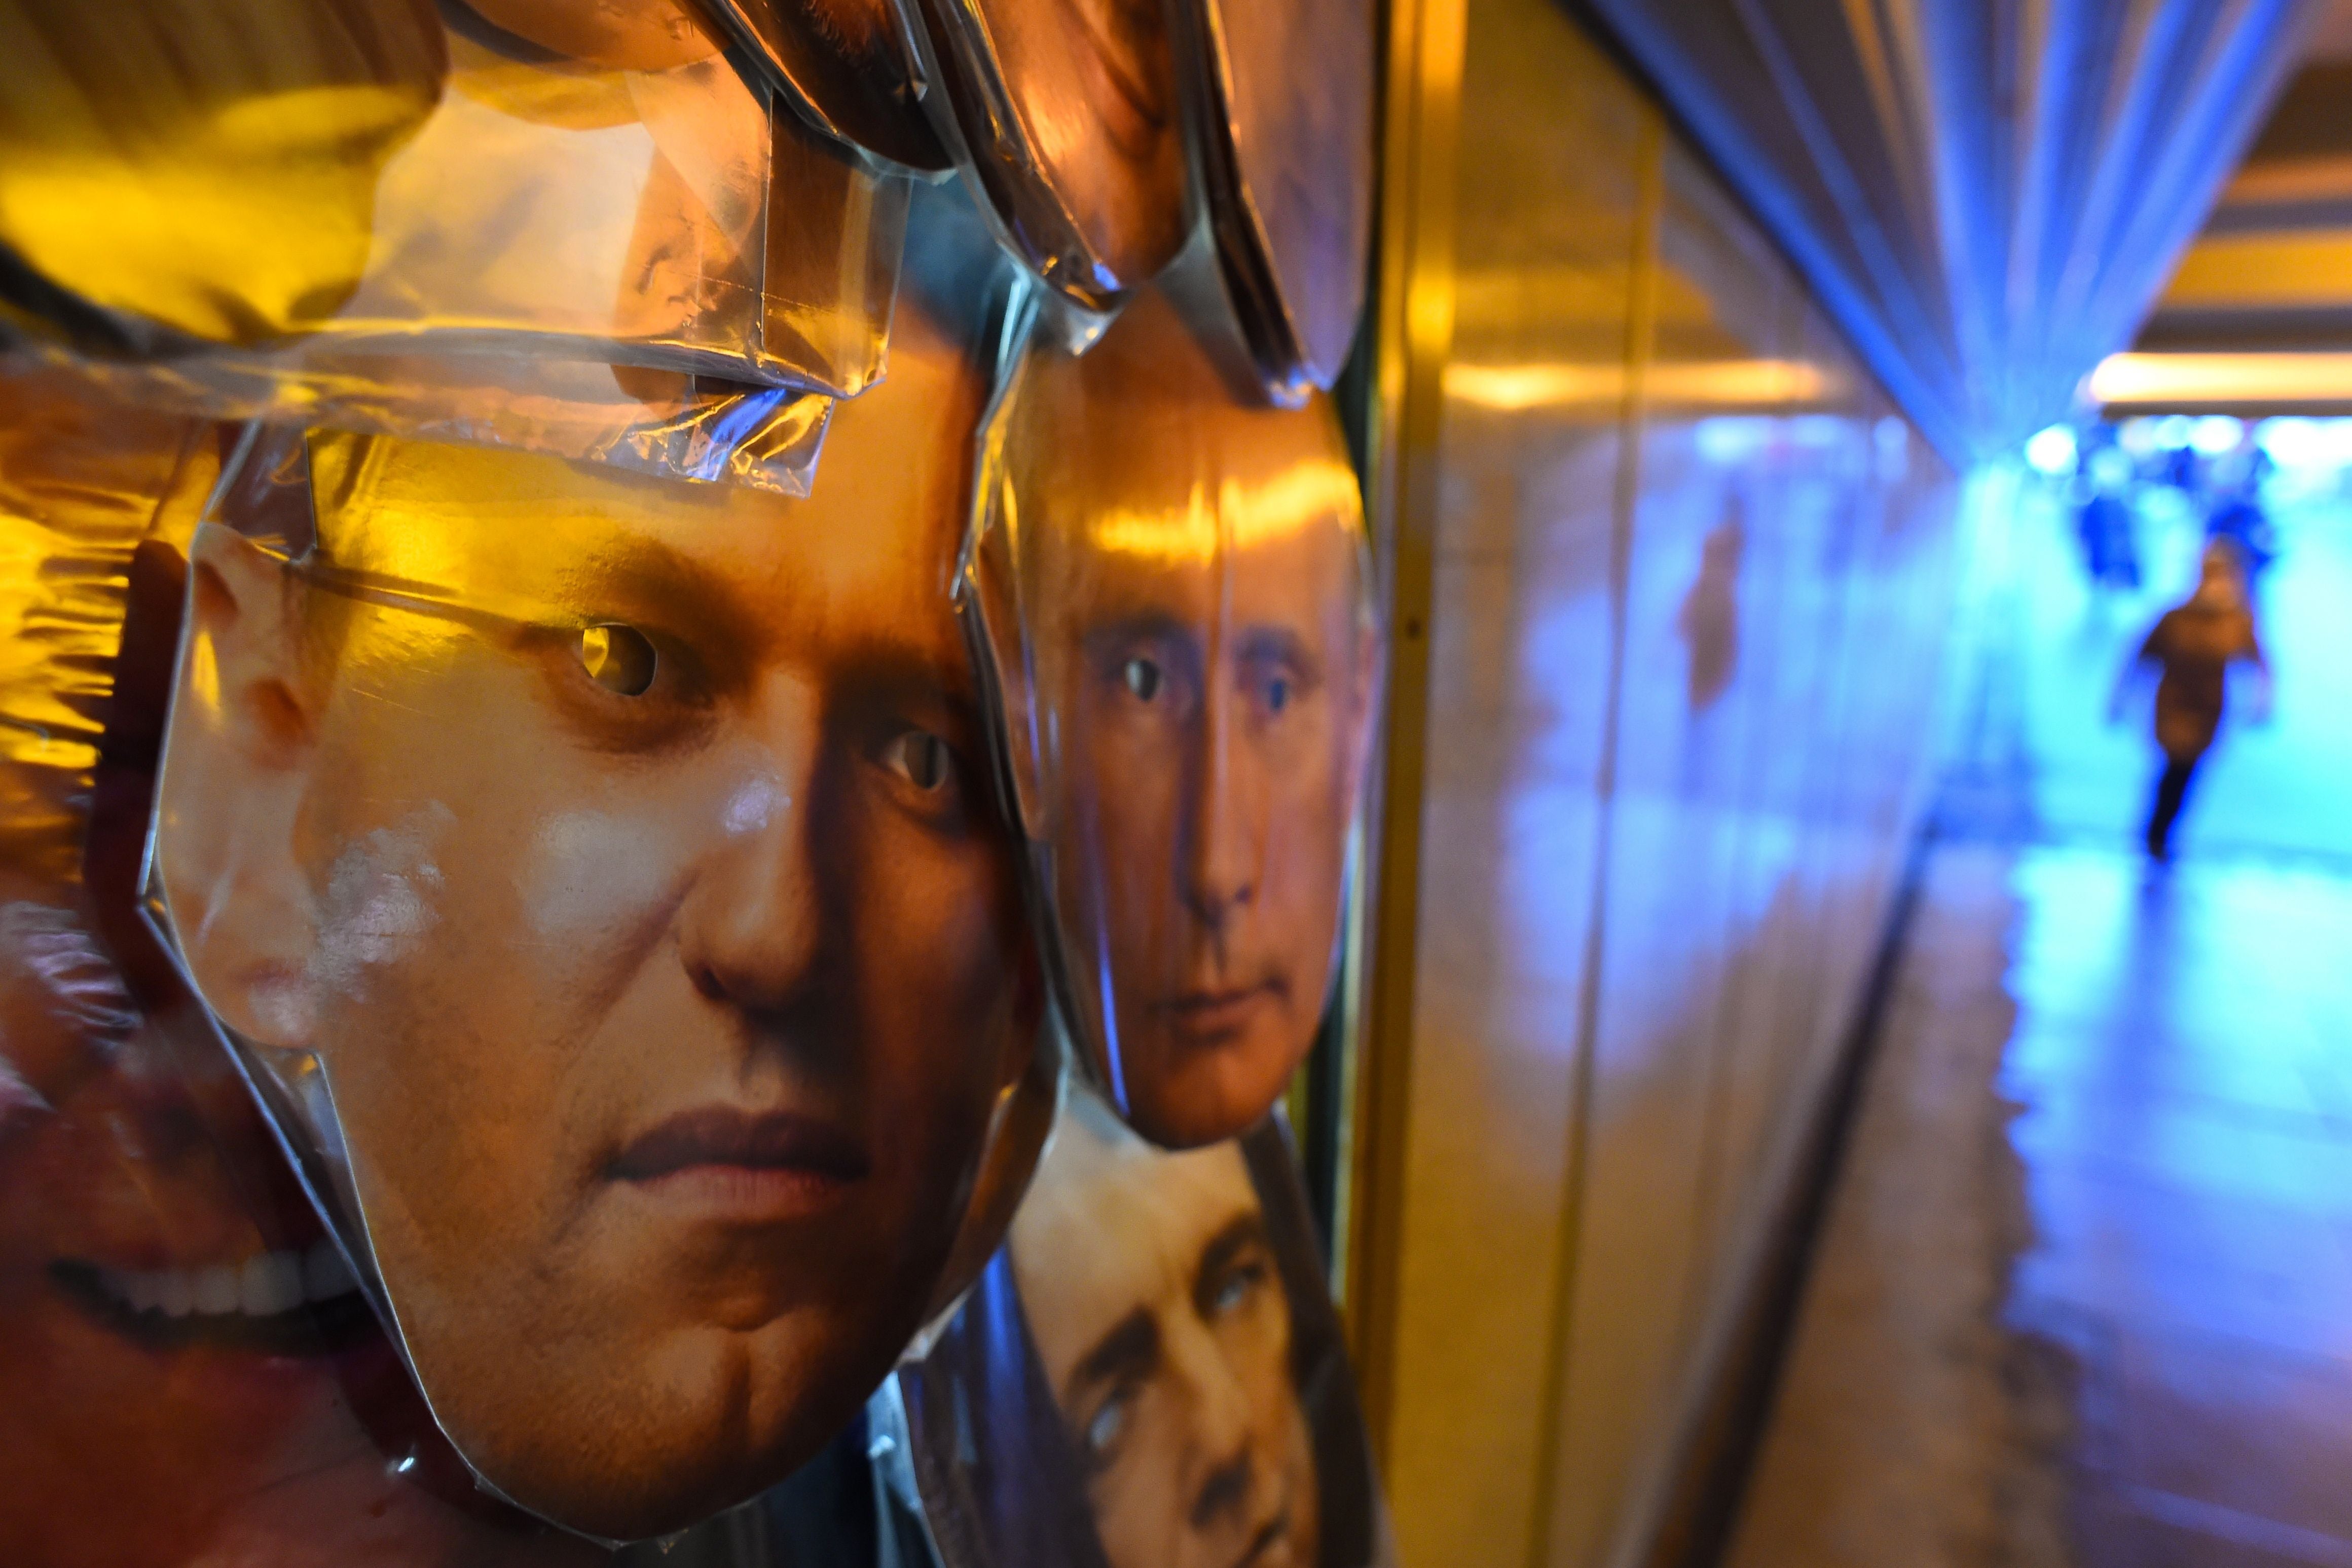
[898,1091,1395,1568]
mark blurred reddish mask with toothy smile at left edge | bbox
[0,374,604,1568]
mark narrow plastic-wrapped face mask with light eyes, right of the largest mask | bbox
[964,291,1381,1145]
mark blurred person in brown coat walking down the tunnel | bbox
[2110,541,2270,861]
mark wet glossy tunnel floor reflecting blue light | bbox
[1731,484,2352,1568]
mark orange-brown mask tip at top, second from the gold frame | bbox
[905,0,1190,313]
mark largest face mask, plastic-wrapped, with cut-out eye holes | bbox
[148,288,1056,1540]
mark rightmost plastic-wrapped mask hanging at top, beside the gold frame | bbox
[1173,0,1374,402]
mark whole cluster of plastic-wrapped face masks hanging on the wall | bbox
[0,0,1381,1568]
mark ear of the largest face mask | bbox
[155,524,317,1049]
